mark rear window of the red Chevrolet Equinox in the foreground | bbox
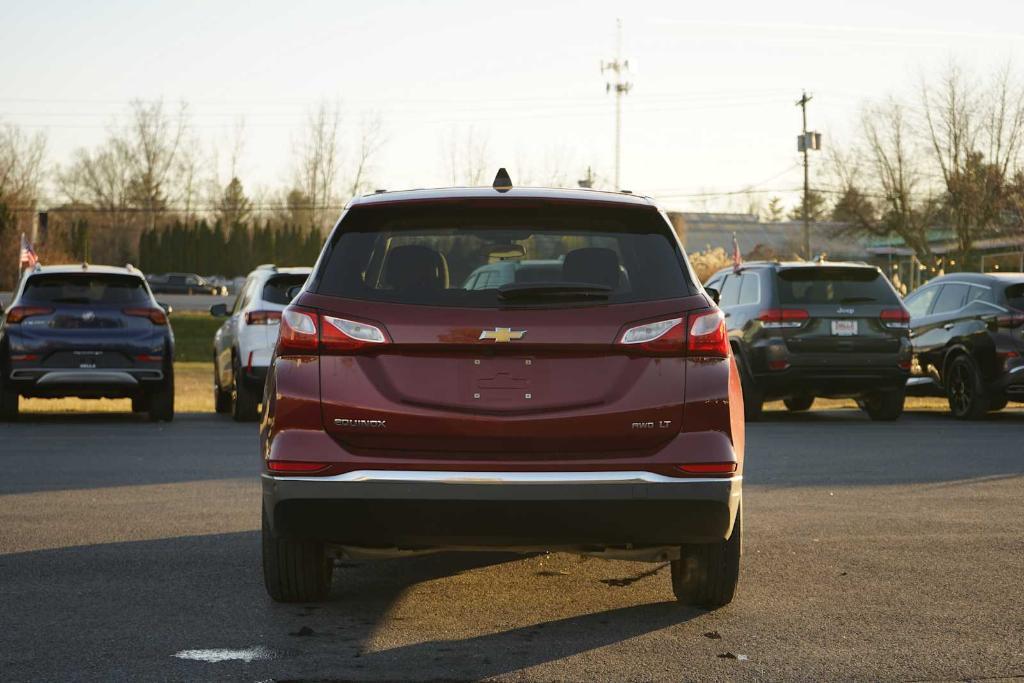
[314,201,696,307]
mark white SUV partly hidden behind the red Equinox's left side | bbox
[210,265,310,422]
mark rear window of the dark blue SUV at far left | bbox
[22,272,151,305]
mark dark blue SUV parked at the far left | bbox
[0,264,174,421]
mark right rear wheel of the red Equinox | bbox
[672,501,743,608]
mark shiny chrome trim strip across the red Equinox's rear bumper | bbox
[263,470,743,484]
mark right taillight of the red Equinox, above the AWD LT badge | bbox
[618,308,729,358]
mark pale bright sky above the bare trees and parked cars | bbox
[0,0,1024,208]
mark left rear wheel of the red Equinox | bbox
[262,510,334,602]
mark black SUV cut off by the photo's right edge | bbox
[906,272,1024,420]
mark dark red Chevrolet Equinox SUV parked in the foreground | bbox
[260,179,743,606]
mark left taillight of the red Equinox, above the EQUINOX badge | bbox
[278,306,388,355]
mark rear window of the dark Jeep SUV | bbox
[778,266,899,305]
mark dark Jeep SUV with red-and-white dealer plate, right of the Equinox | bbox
[706,261,911,420]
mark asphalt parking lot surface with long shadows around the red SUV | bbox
[0,409,1024,681]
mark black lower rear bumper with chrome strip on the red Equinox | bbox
[263,470,742,549]
